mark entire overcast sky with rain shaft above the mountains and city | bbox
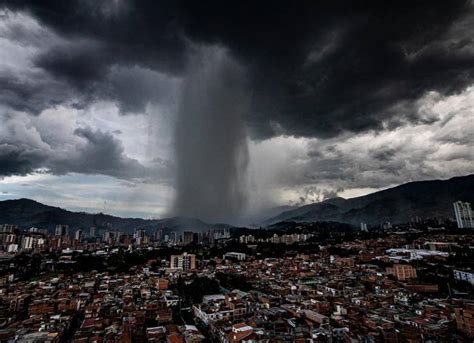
[0,0,474,221]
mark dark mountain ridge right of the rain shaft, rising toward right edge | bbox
[264,174,474,225]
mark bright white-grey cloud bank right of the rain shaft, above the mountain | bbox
[250,87,474,205]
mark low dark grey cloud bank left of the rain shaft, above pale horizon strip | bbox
[0,116,172,180]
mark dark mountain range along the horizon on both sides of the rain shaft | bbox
[0,174,474,232]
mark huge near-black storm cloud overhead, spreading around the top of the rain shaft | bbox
[6,0,474,138]
